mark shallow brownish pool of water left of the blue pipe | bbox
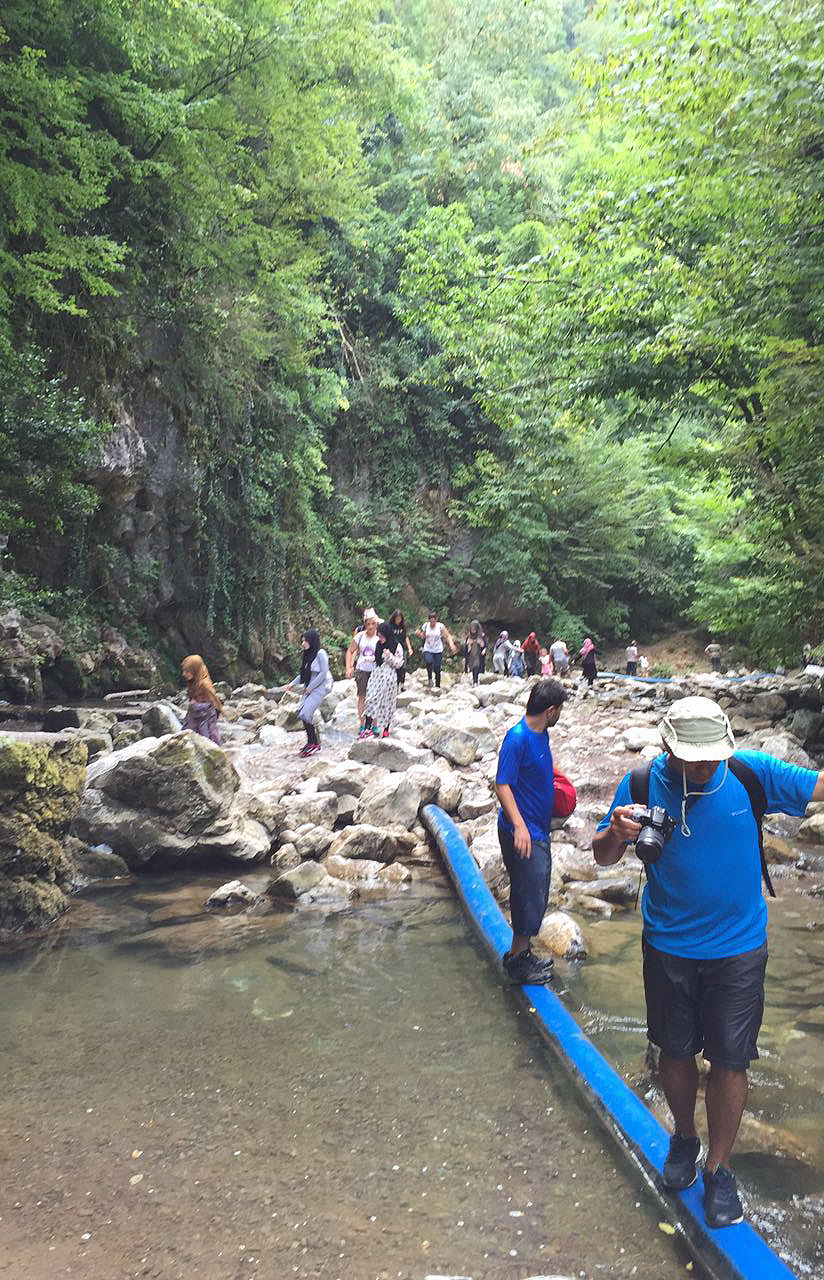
[0,873,697,1280]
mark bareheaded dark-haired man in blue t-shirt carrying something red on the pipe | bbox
[495,680,567,983]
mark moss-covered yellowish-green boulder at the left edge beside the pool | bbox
[0,733,86,936]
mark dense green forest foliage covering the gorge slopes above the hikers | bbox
[0,0,824,660]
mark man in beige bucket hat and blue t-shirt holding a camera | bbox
[592,698,824,1228]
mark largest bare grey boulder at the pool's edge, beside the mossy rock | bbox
[75,732,273,868]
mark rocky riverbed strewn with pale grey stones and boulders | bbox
[0,672,824,959]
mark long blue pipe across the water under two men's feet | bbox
[421,804,795,1280]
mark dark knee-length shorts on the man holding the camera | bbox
[642,938,766,1071]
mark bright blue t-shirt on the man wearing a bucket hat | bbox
[598,751,818,960]
